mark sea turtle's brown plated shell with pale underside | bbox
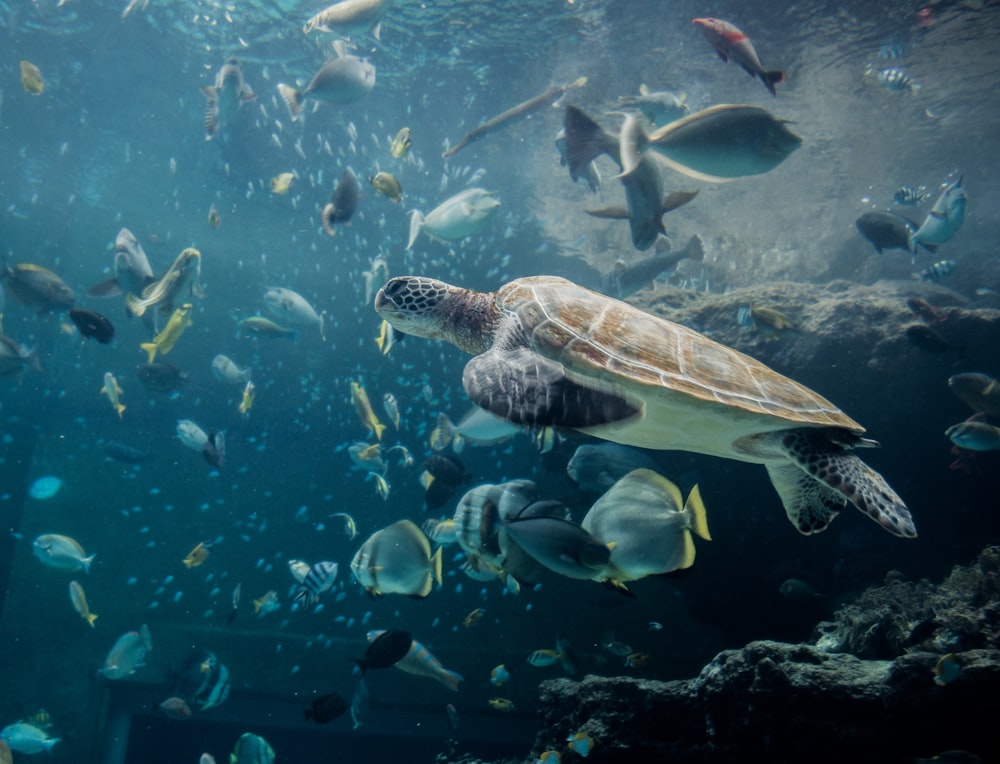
[496,276,864,454]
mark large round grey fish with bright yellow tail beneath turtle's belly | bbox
[580,468,711,584]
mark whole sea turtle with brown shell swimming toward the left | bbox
[375,276,916,538]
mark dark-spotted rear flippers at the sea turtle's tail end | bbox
[767,428,917,538]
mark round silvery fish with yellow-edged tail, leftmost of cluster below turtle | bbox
[351,520,441,597]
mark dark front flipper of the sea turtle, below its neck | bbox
[462,348,642,429]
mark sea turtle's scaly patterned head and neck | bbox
[375,276,496,354]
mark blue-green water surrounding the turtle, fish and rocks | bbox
[0,0,1000,762]
